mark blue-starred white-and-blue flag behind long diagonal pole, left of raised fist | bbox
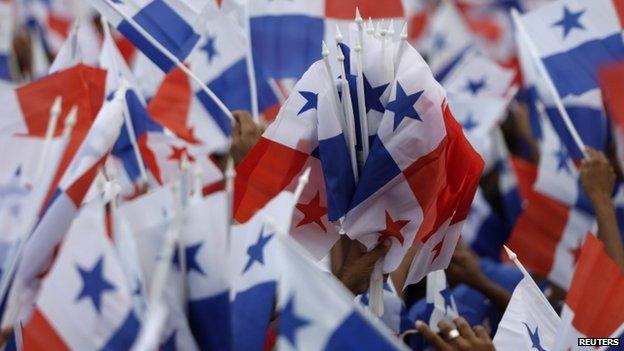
[188,8,278,126]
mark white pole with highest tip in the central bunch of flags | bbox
[353,7,370,165]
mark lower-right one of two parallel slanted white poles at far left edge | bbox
[0,106,78,329]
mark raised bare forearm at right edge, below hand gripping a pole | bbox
[594,199,624,270]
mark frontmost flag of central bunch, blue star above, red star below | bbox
[343,37,483,282]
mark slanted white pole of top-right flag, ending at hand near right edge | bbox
[511,9,588,159]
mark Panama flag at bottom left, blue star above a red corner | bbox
[23,201,140,350]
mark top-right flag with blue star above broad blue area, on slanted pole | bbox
[521,0,624,159]
